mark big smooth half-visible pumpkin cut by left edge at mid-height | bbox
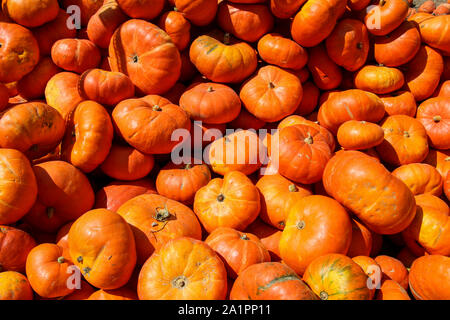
[0,148,38,225]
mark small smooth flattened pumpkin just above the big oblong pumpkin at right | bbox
[337,120,384,150]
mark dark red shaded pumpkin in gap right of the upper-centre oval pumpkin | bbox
[308,45,343,90]
